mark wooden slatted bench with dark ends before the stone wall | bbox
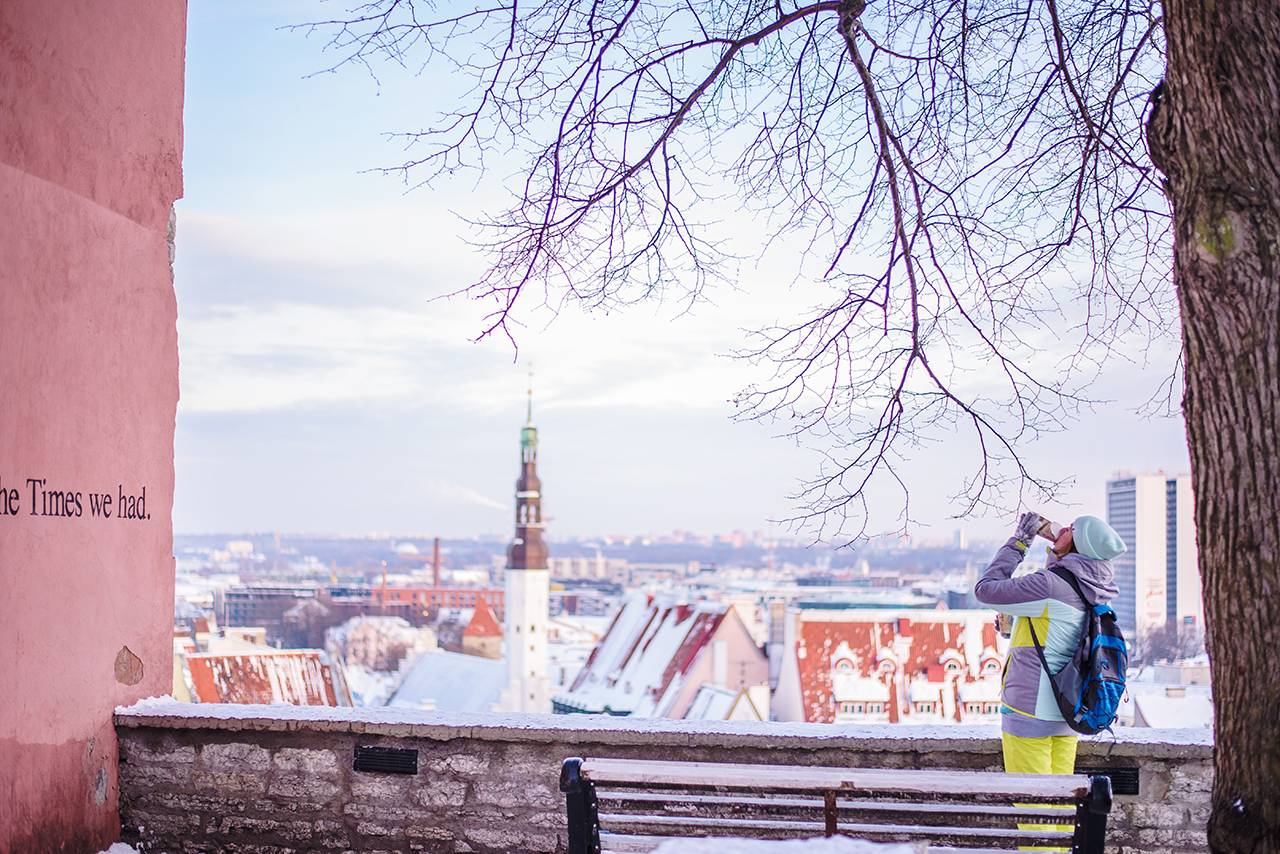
[559,758,1111,854]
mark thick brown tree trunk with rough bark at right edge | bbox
[1148,0,1280,854]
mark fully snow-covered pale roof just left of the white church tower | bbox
[387,649,507,712]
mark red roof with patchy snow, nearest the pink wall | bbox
[187,649,351,705]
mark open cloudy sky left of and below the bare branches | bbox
[174,0,1188,539]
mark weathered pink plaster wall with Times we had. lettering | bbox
[0,0,186,854]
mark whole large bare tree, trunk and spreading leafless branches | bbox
[304,0,1280,851]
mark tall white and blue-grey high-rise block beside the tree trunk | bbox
[1107,474,1204,641]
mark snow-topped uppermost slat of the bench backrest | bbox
[582,759,1089,800]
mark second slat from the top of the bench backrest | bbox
[596,789,1075,825]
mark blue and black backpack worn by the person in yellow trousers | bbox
[1028,566,1129,735]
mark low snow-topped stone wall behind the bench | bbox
[116,703,1212,854]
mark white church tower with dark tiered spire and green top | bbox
[500,388,552,712]
